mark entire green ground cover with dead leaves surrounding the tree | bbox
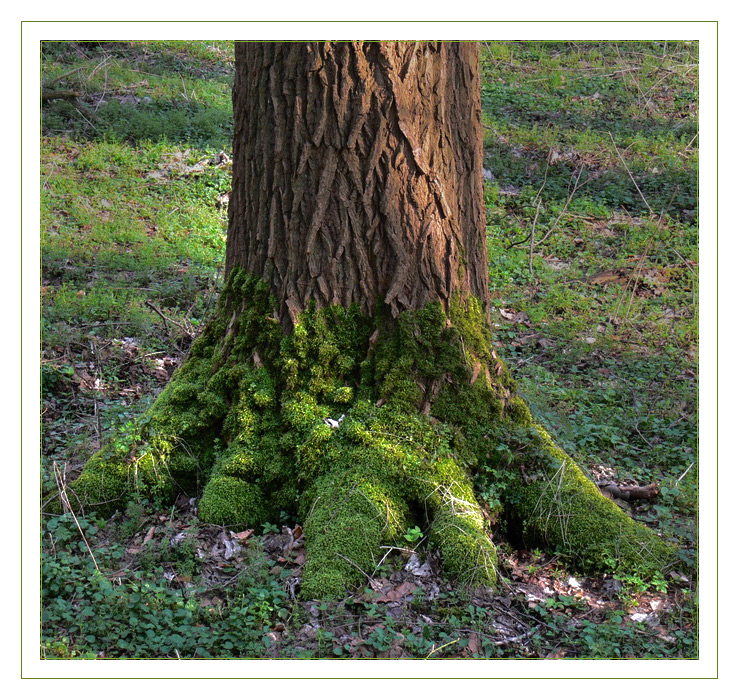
[42,42,697,658]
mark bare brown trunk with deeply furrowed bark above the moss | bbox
[226,42,488,329]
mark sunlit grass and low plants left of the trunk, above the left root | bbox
[41,42,233,480]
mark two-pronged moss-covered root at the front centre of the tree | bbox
[292,403,496,597]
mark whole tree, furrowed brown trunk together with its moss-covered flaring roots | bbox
[60,42,674,597]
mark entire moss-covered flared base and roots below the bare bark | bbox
[65,271,684,598]
